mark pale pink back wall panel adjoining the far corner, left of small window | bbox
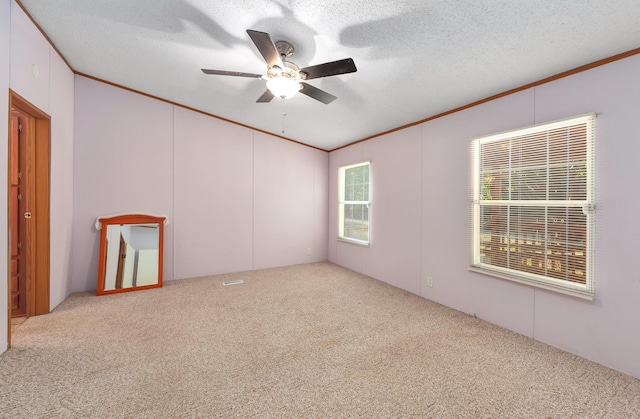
[253,133,328,269]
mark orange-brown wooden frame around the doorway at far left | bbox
[6,89,51,347]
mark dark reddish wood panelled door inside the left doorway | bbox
[9,112,28,317]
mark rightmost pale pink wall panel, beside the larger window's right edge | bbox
[535,55,640,377]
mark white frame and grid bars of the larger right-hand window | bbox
[469,113,596,300]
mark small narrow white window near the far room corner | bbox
[338,162,371,244]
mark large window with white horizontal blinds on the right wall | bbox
[470,115,595,299]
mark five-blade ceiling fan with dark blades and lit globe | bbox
[202,29,357,104]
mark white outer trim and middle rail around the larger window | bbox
[468,113,596,300]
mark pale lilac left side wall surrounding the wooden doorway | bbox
[5,2,74,316]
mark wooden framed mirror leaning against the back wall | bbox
[96,214,166,295]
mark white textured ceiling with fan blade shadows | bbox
[21,0,640,150]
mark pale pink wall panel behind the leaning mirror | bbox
[71,76,173,292]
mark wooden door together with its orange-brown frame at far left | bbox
[7,90,51,347]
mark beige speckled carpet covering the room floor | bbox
[0,263,640,418]
